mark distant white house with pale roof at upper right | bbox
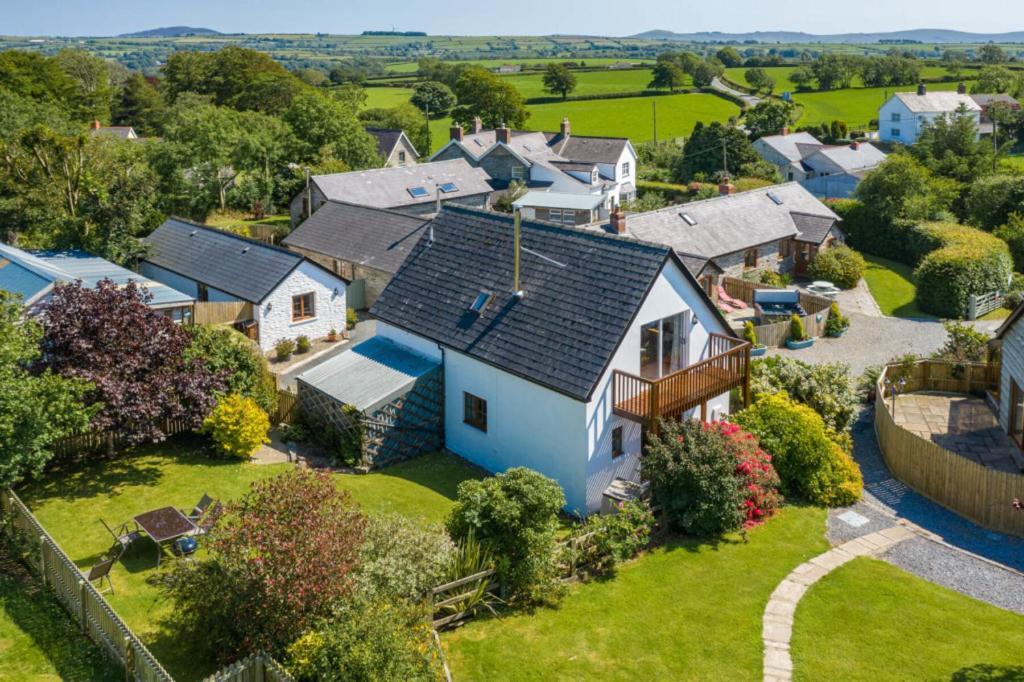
[879,83,981,144]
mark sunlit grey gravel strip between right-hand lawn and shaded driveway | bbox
[881,537,1024,613]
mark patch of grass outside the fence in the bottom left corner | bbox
[0,549,124,682]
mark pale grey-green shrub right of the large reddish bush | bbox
[355,515,455,601]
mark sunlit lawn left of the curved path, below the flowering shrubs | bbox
[443,507,826,680]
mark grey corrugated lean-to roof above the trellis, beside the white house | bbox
[298,337,440,413]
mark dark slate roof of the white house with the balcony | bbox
[370,205,729,401]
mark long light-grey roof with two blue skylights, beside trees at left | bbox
[311,159,493,208]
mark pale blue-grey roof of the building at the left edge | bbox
[0,244,195,308]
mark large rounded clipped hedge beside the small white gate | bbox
[913,223,1013,317]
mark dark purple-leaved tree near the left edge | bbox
[42,280,223,444]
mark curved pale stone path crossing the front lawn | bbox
[762,525,914,682]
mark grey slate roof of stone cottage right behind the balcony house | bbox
[596,182,839,258]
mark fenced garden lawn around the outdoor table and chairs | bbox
[20,438,477,680]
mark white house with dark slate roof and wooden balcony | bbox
[364,206,750,513]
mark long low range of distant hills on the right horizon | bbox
[630,29,1024,44]
